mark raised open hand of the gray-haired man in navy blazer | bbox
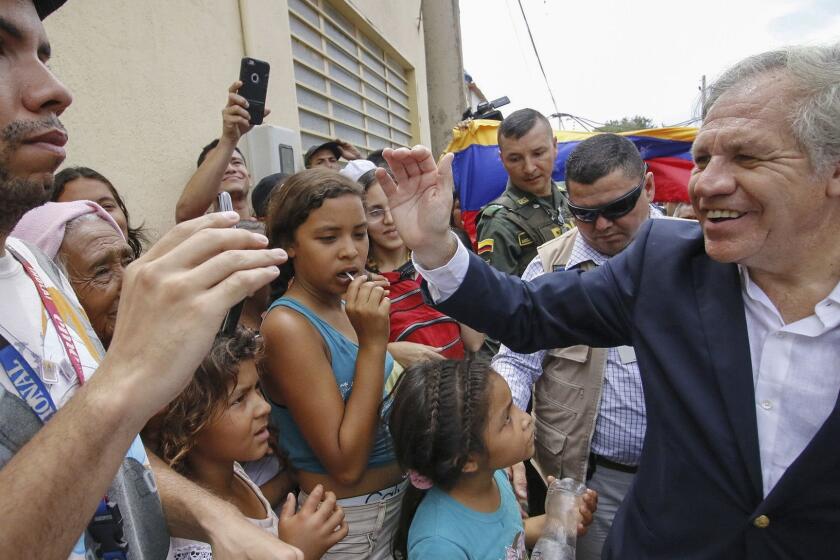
[376,146,456,268]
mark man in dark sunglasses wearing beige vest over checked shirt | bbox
[492,134,661,560]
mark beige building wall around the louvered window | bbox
[46,0,430,242]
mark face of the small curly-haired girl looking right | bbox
[190,360,271,461]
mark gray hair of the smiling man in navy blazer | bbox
[703,43,840,173]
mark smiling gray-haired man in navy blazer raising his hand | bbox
[380,41,840,560]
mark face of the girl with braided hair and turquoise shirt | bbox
[484,371,534,470]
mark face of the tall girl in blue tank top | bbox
[287,194,368,295]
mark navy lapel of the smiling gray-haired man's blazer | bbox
[692,253,763,498]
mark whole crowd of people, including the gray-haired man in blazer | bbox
[0,0,840,560]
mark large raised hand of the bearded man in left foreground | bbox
[102,212,286,430]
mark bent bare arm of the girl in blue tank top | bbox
[262,277,390,486]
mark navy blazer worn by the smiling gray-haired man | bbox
[430,220,840,560]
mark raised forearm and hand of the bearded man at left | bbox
[0,213,288,560]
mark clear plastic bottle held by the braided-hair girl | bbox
[531,478,586,560]
